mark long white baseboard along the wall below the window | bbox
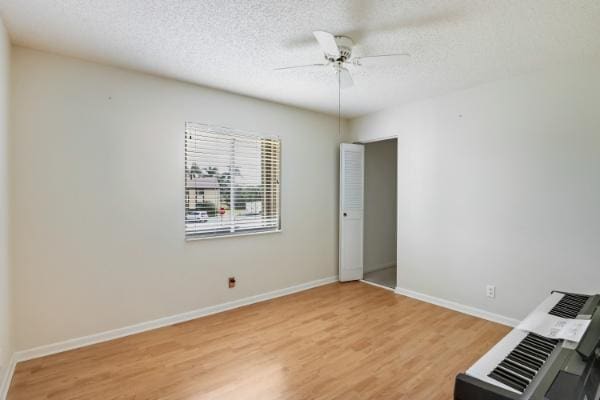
[15,276,338,364]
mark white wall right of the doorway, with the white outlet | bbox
[351,62,600,318]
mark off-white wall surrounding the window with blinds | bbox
[12,47,341,350]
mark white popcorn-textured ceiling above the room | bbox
[0,0,600,117]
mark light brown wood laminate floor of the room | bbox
[8,282,509,400]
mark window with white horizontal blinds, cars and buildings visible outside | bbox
[185,123,281,238]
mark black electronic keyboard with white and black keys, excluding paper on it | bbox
[454,292,600,400]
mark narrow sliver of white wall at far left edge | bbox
[0,19,12,384]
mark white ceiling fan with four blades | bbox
[275,31,410,88]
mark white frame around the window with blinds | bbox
[183,121,283,241]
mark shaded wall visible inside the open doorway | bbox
[364,140,397,272]
